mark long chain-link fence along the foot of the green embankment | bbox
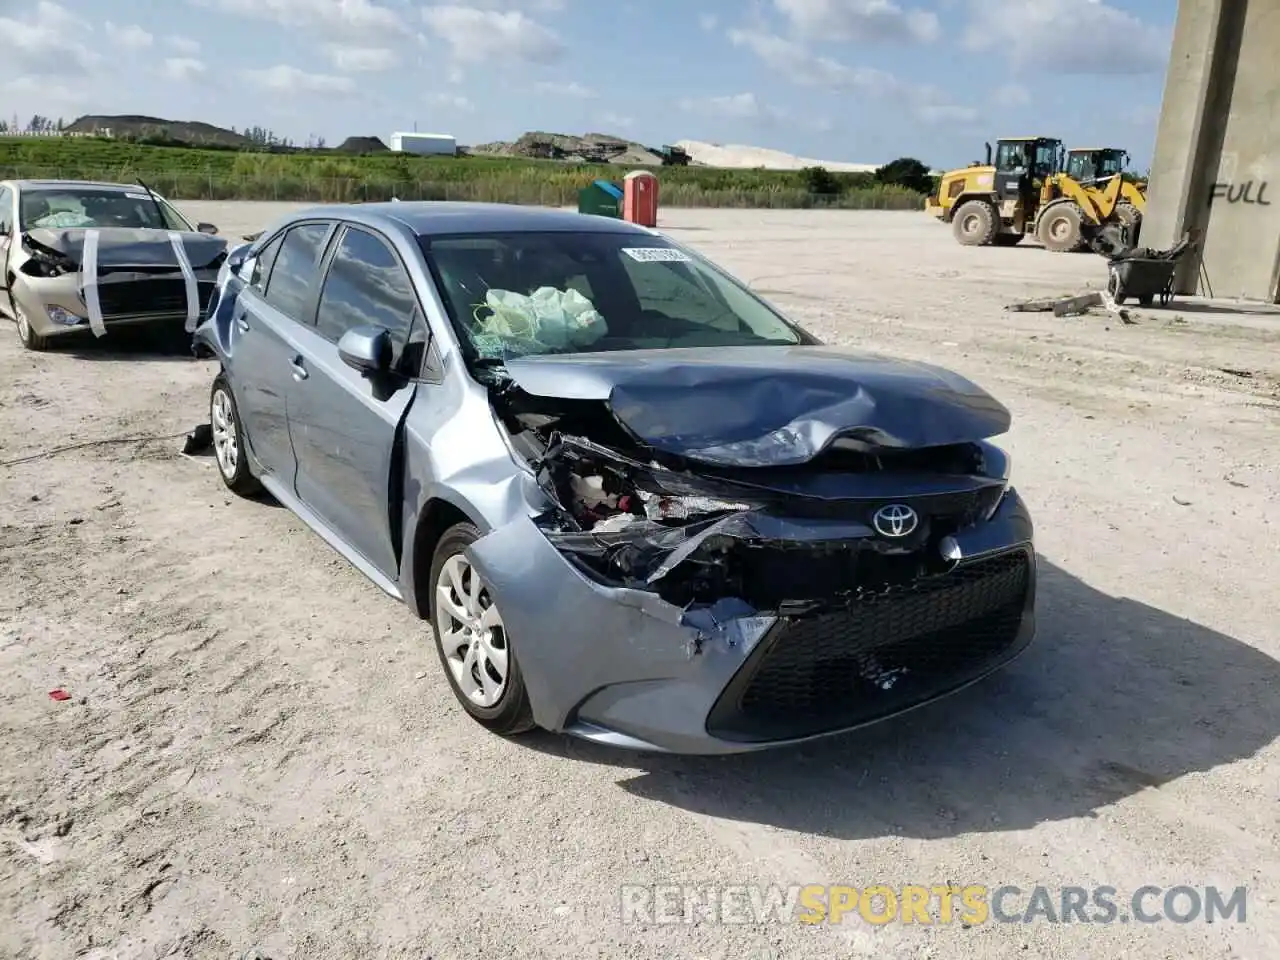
[0,166,924,210]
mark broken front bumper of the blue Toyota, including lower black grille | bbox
[468,488,1036,754]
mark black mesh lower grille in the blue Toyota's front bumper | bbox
[707,550,1032,740]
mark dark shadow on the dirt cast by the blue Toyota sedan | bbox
[522,558,1280,838]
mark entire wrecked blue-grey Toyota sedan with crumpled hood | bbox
[196,202,1036,754]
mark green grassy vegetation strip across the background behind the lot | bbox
[0,137,923,210]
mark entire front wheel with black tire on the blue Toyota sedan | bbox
[429,522,536,736]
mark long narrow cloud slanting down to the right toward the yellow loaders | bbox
[730,29,978,123]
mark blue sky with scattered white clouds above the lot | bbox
[0,0,1176,166]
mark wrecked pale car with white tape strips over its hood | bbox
[0,180,227,351]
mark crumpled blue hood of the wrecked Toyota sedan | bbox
[506,346,1011,467]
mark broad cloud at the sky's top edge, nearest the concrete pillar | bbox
[964,0,1172,76]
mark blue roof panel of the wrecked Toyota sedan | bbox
[273,200,653,237]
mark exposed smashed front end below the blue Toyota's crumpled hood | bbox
[490,375,1005,616]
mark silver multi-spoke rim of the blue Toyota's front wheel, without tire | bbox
[435,553,509,708]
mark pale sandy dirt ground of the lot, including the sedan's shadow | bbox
[0,204,1280,960]
